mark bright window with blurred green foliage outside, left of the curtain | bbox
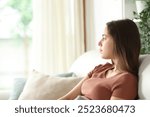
[0,0,32,89]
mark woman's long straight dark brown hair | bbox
[106,19,141,76]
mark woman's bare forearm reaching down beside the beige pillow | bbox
[59,76,89,100]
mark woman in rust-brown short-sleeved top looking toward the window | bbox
[60,19,140,100]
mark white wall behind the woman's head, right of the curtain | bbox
[86,0,136,50]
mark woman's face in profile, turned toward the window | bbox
[98,26,114,59]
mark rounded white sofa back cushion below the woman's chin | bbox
[70,50,110,76]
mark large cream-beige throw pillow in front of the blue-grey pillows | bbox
[19,71,82,100]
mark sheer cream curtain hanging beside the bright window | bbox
[32,0,85,73]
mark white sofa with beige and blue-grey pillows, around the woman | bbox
[0,50,150,100]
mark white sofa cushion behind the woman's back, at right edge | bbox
[138,55,150,99]
